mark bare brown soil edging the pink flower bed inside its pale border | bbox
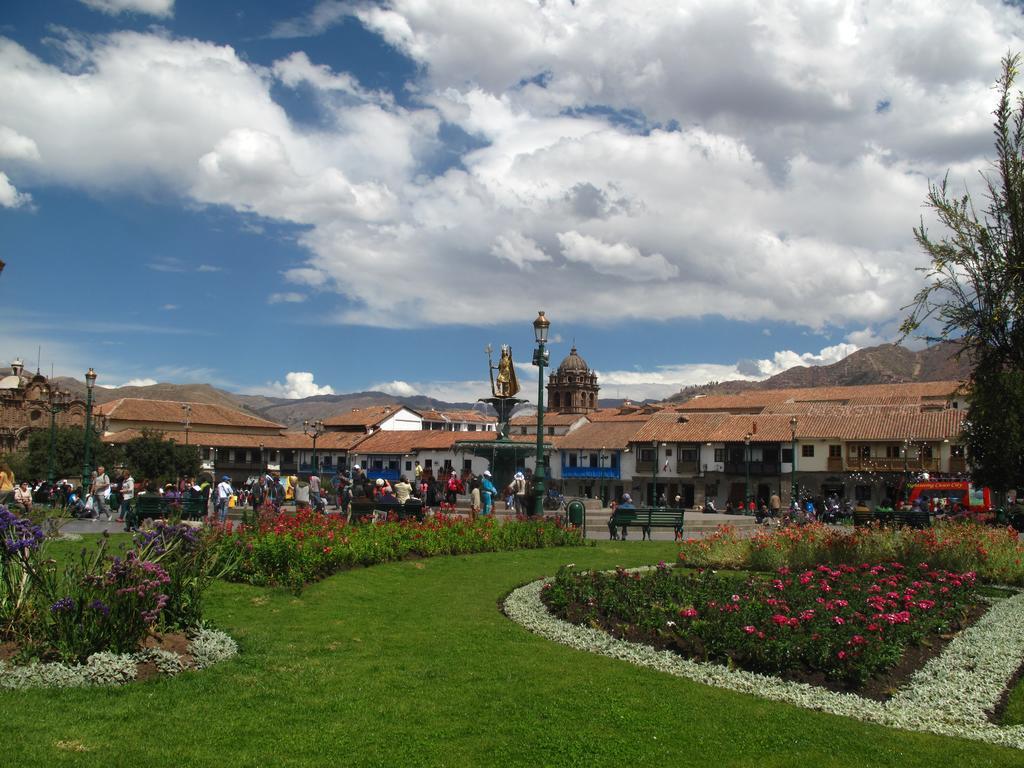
[542,596,988,701]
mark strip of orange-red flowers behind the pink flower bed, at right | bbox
[679,522,1024,586]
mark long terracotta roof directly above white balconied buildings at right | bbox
[631,406,965,442]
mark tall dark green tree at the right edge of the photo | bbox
[901,55,1024,489]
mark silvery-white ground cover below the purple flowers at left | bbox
[0,628,239,688]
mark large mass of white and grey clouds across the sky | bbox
[0,0,1024,339]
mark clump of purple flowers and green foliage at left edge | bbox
[0,506,232,677]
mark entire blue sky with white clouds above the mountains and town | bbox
[0,0,1024,399]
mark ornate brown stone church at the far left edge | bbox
[0,359,85,453]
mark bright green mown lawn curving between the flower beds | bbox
[0,542,1024,768]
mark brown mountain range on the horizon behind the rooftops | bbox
[49,342,971,428]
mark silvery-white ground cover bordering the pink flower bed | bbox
[505,579,1024,750]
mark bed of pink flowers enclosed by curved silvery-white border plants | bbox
[544,563,978,688]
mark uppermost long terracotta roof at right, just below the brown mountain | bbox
[677,381,963,411]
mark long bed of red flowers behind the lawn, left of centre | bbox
[214,510,585,591]
